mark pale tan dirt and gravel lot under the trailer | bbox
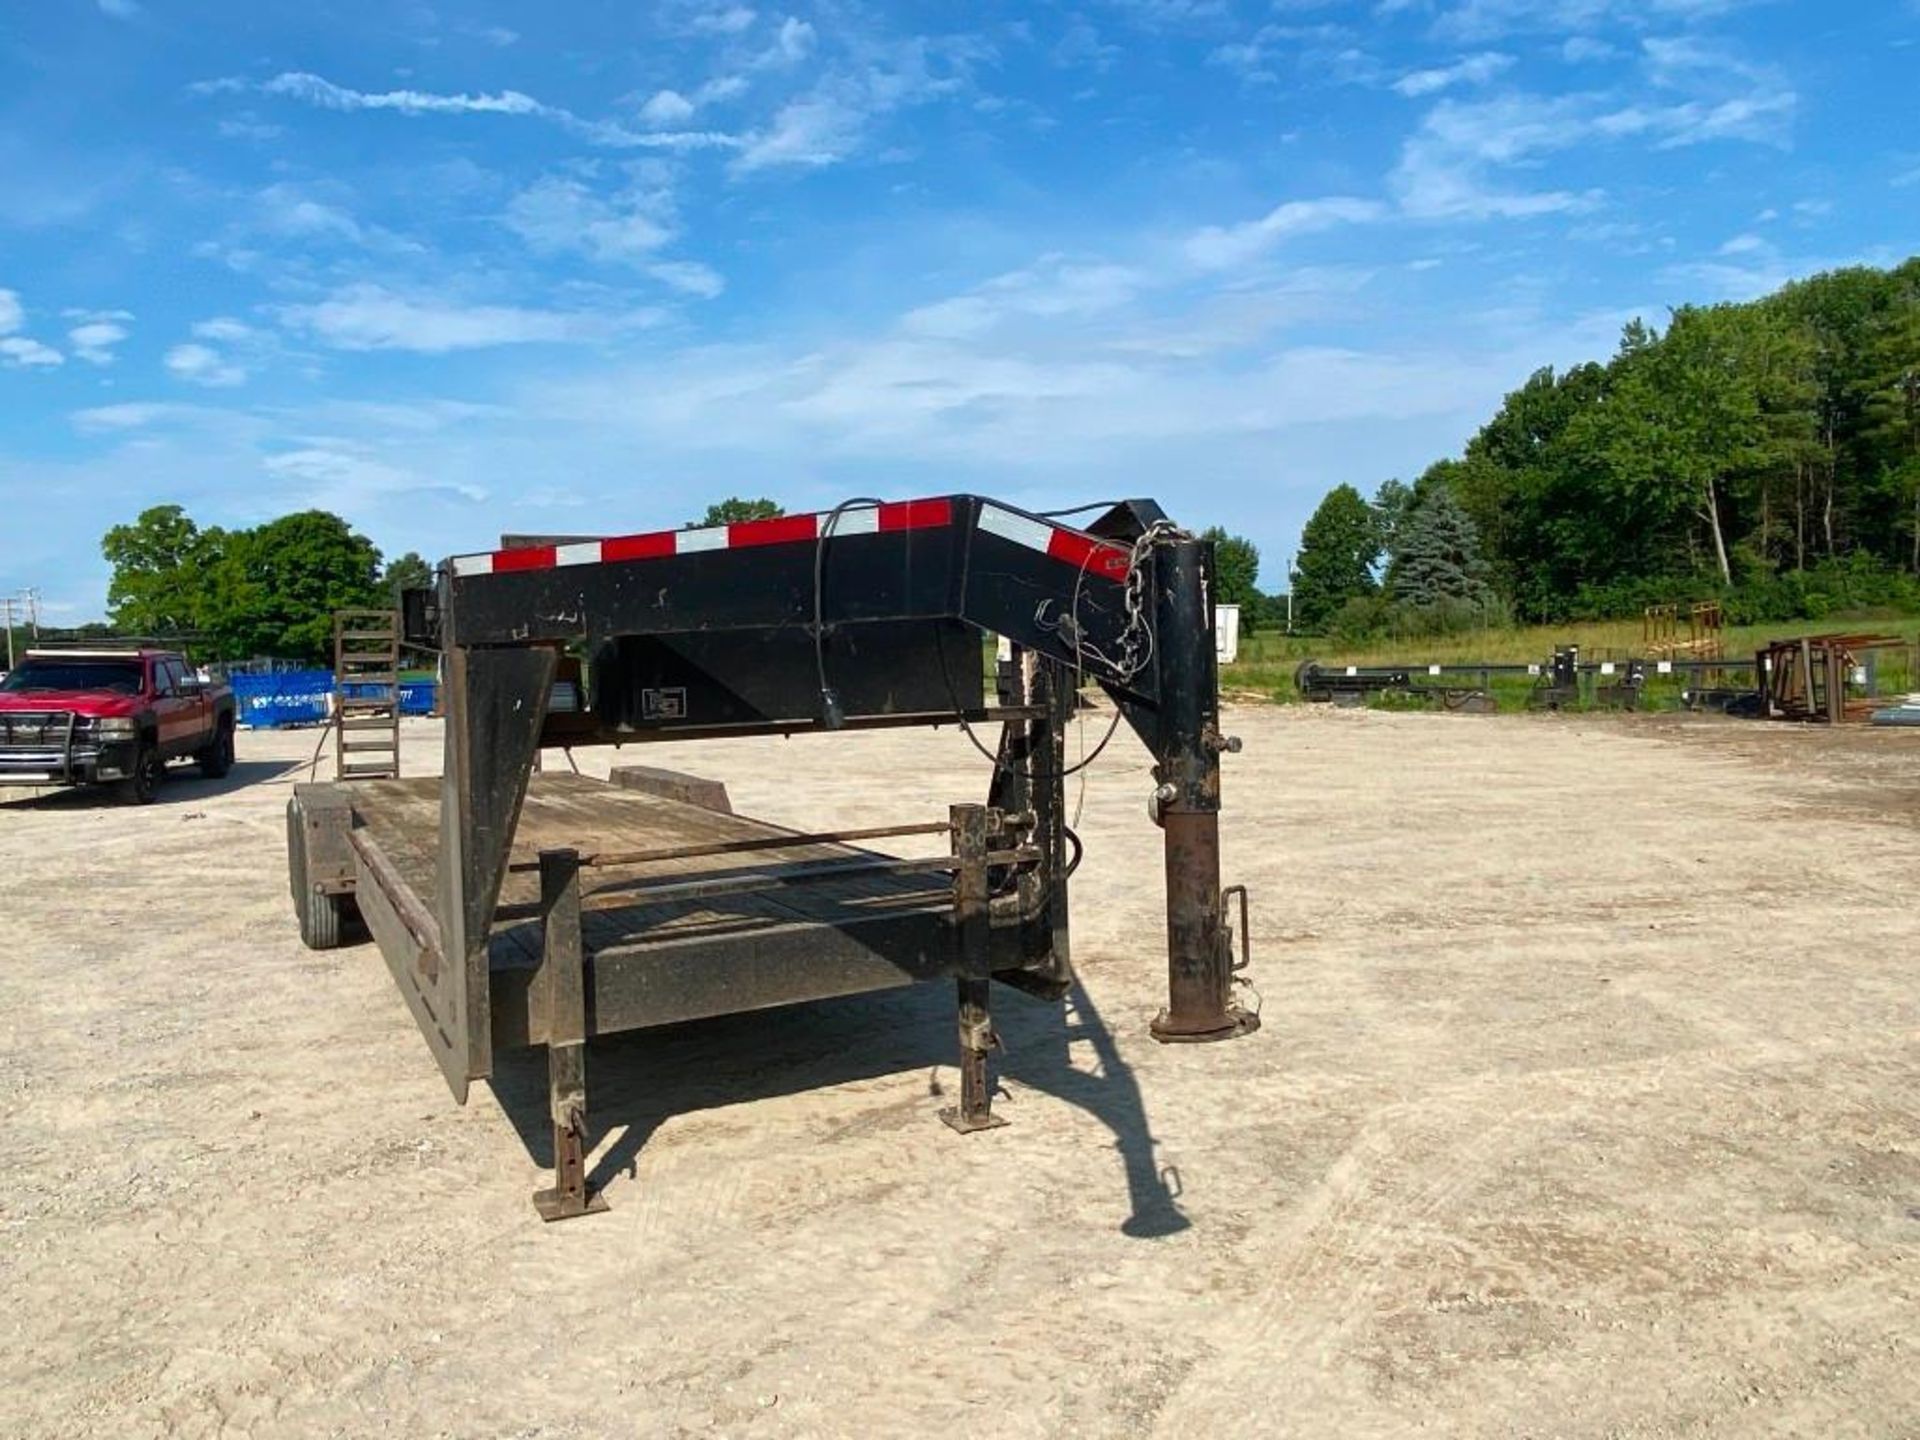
[0,708,1920,1440]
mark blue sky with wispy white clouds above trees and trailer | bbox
[0,0,1920,620]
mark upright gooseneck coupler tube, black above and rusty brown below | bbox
[1152,538,1260,1043]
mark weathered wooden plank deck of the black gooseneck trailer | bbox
[353,774,952,970]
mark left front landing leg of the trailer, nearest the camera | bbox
[534,851,607,1221]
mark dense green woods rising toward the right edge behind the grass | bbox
[1294,257,1920,632]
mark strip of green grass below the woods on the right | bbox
[1219,612,1920,708]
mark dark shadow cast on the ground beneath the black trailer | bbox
[492,981,1192,1238]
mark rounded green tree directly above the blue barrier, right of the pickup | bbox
[207,511,386,662]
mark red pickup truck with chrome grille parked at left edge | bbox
[0,649,234,804]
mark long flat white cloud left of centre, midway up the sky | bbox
[282,284,659,355]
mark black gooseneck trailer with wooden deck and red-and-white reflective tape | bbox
[288,495,1258,1219]
